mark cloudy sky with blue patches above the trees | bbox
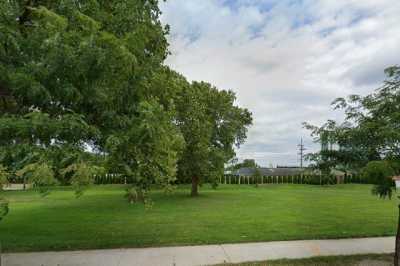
[162,0,400,166]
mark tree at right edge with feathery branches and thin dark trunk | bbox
[306,66,400,265]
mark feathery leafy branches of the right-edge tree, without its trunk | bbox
[305,66,400,177]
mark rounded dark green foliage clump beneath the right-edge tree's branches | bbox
[362,161,394,199]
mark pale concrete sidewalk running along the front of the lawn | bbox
[2,237,395,266]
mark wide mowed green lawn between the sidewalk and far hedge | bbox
[0,185,397,252]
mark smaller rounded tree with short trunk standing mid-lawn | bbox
[177,82,252,196]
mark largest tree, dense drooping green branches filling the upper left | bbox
[0,0,179,195]
